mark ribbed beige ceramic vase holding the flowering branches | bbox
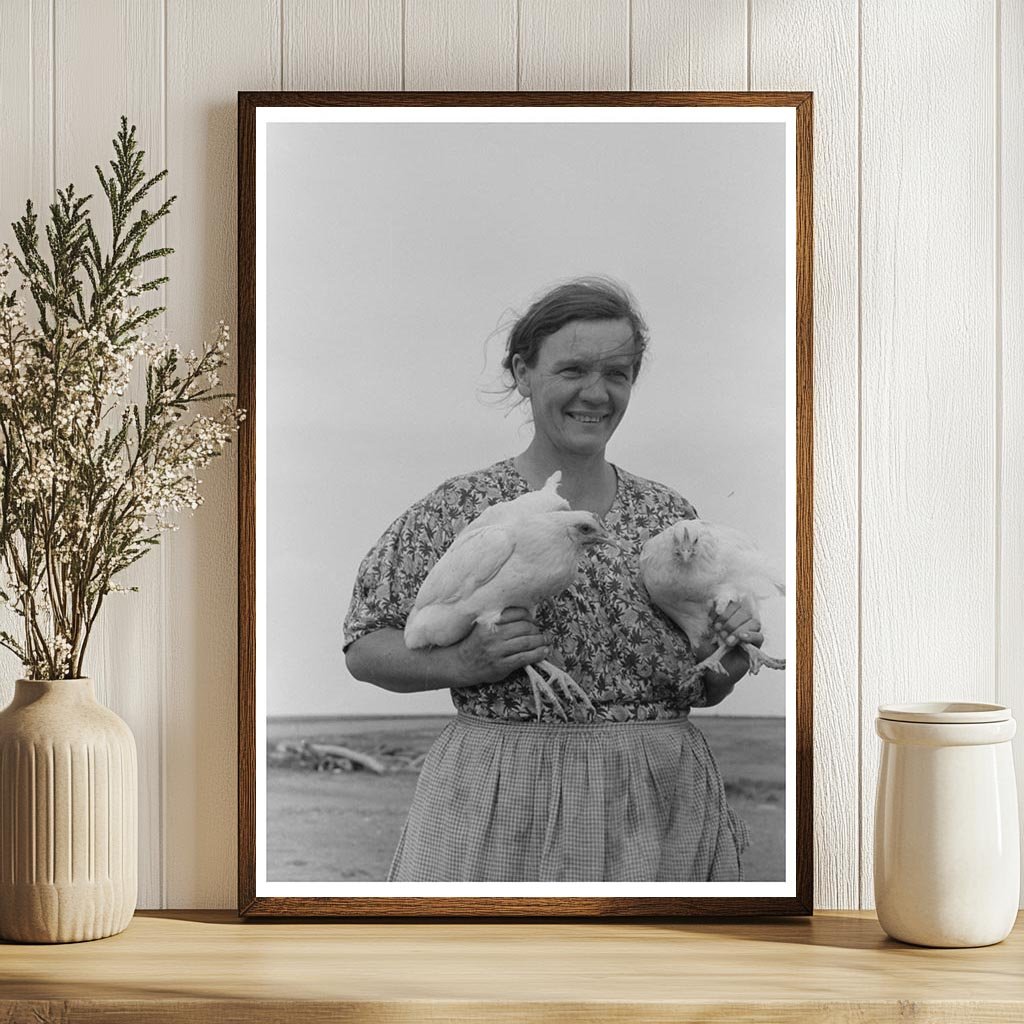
[0,679,138,942]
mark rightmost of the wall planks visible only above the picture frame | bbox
[631,0,748,90]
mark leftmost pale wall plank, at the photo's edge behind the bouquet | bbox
[0,0,53,708]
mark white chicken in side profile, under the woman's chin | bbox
[404,474,617,719]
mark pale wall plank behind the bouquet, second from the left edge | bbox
[54,0,164,907]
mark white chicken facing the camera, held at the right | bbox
[640,519,785,675]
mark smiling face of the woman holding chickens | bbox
[512,319,636,455]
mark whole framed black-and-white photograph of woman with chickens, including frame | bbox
[239,92,813,918]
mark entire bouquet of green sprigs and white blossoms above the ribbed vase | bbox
[0,118,244,679]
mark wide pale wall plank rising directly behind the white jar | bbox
[860,0,996,906]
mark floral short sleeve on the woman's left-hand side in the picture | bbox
[342,503,453,650]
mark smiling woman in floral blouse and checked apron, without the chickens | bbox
[345,279,763,882]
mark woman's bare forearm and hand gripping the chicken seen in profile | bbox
[345,608,548,693]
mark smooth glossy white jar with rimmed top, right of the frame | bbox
[874,703,1020,947]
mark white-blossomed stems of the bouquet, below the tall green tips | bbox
[0,246,244,678]
